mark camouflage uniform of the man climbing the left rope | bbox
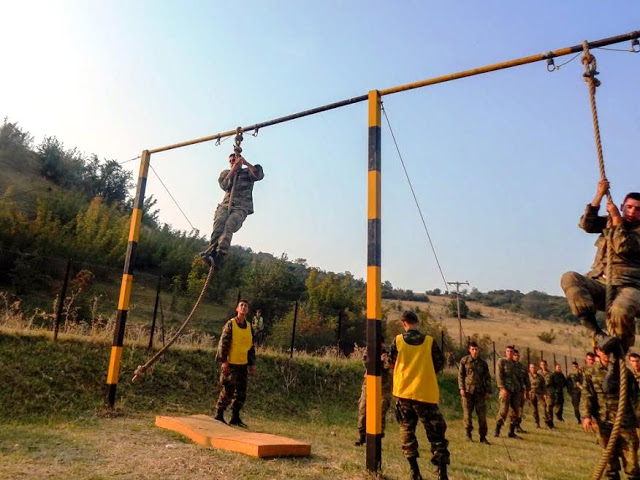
[209,165,264,255]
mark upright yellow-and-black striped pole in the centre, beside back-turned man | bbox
[366,90,382,472]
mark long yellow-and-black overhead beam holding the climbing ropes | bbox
[149,30,640,154]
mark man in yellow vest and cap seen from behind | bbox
[391,311,449,480]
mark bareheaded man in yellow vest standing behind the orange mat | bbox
[214,300,256,427]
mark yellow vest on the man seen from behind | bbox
[393,335,440,404]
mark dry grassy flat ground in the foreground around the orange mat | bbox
[0,411,601,480]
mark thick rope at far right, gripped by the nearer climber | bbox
[582,40,627,480]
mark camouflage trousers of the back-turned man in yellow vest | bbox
[396,398,449,465]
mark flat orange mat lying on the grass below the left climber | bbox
[156,415,311,457]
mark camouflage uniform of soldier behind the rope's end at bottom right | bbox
[580,366,640,480]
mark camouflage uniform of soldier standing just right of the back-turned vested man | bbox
[458,355,492,438]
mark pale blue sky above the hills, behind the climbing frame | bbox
[0,0,640,294]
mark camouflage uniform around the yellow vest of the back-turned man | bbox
[391,329,449,466]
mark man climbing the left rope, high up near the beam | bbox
[200,128,264,270]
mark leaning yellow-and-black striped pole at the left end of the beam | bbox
[107,150,151,407]
